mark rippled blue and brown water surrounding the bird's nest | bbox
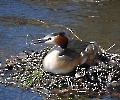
[0,0,120,100]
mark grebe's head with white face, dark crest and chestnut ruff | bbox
[34,32,68,49]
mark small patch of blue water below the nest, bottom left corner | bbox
[0,86,42,100]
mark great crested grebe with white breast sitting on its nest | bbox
[33,32,98,74]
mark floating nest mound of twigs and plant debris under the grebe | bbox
[1,40,120,100]
